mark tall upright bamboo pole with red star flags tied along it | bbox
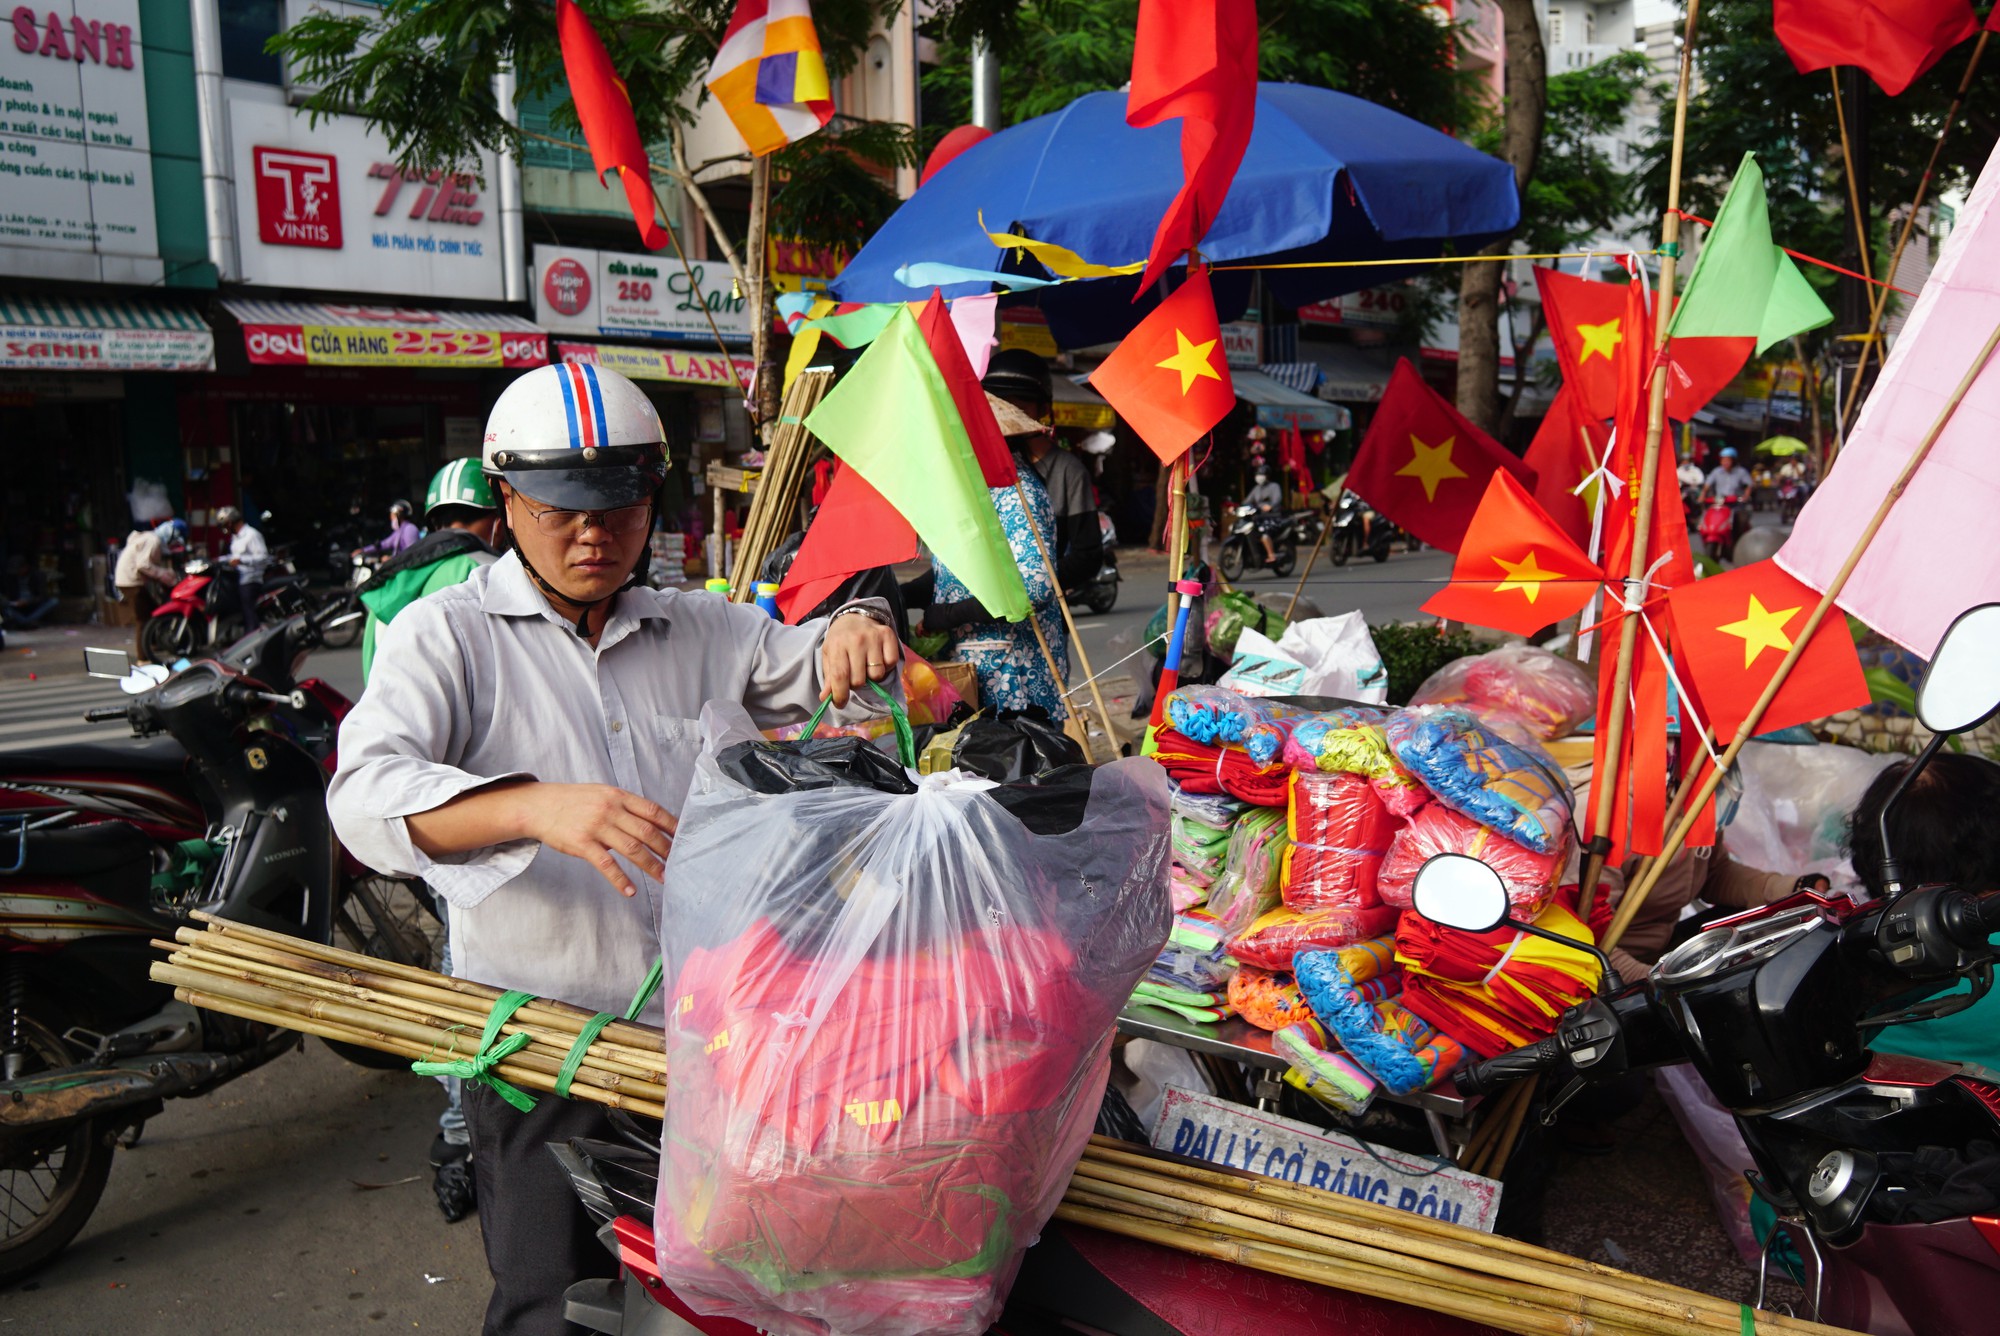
[1578,0,1702,922]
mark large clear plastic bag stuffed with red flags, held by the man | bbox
[656,706,1170,1336]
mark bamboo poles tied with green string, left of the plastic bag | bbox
[152,914,666,1118]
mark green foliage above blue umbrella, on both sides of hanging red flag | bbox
[924,0,1476,128]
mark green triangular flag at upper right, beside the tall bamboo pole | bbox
[1666,154,1834,352]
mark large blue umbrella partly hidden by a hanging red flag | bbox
[830,84,1520,348]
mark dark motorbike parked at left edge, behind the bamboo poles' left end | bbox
[0,596,442,1282]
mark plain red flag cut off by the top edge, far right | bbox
[1772,0,1992,98]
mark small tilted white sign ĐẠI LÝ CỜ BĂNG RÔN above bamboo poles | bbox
[1152,1086,1500,1234]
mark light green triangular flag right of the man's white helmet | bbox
[806,302,1028,622]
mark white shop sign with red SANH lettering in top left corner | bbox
[0,0,160,272]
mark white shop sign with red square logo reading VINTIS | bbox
[230,98,506,300]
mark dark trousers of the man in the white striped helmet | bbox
[464,1082,618,1336]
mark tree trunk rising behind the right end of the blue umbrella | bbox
[1458,0,1548,432]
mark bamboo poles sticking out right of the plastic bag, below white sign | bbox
[1056,1136,1842,1336]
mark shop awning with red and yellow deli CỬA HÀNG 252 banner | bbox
[222,298,548,368]
